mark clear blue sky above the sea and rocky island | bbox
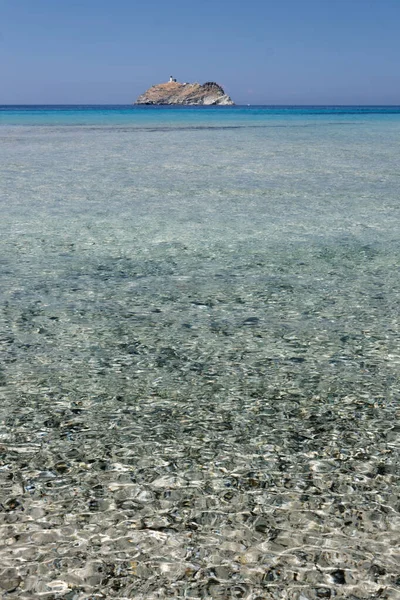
[0,0,400,104]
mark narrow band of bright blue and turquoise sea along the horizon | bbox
[0,105,400,128]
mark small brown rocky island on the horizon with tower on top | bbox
[135,77,234,106]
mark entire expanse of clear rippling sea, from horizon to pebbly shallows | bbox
[0,107,400,600]
